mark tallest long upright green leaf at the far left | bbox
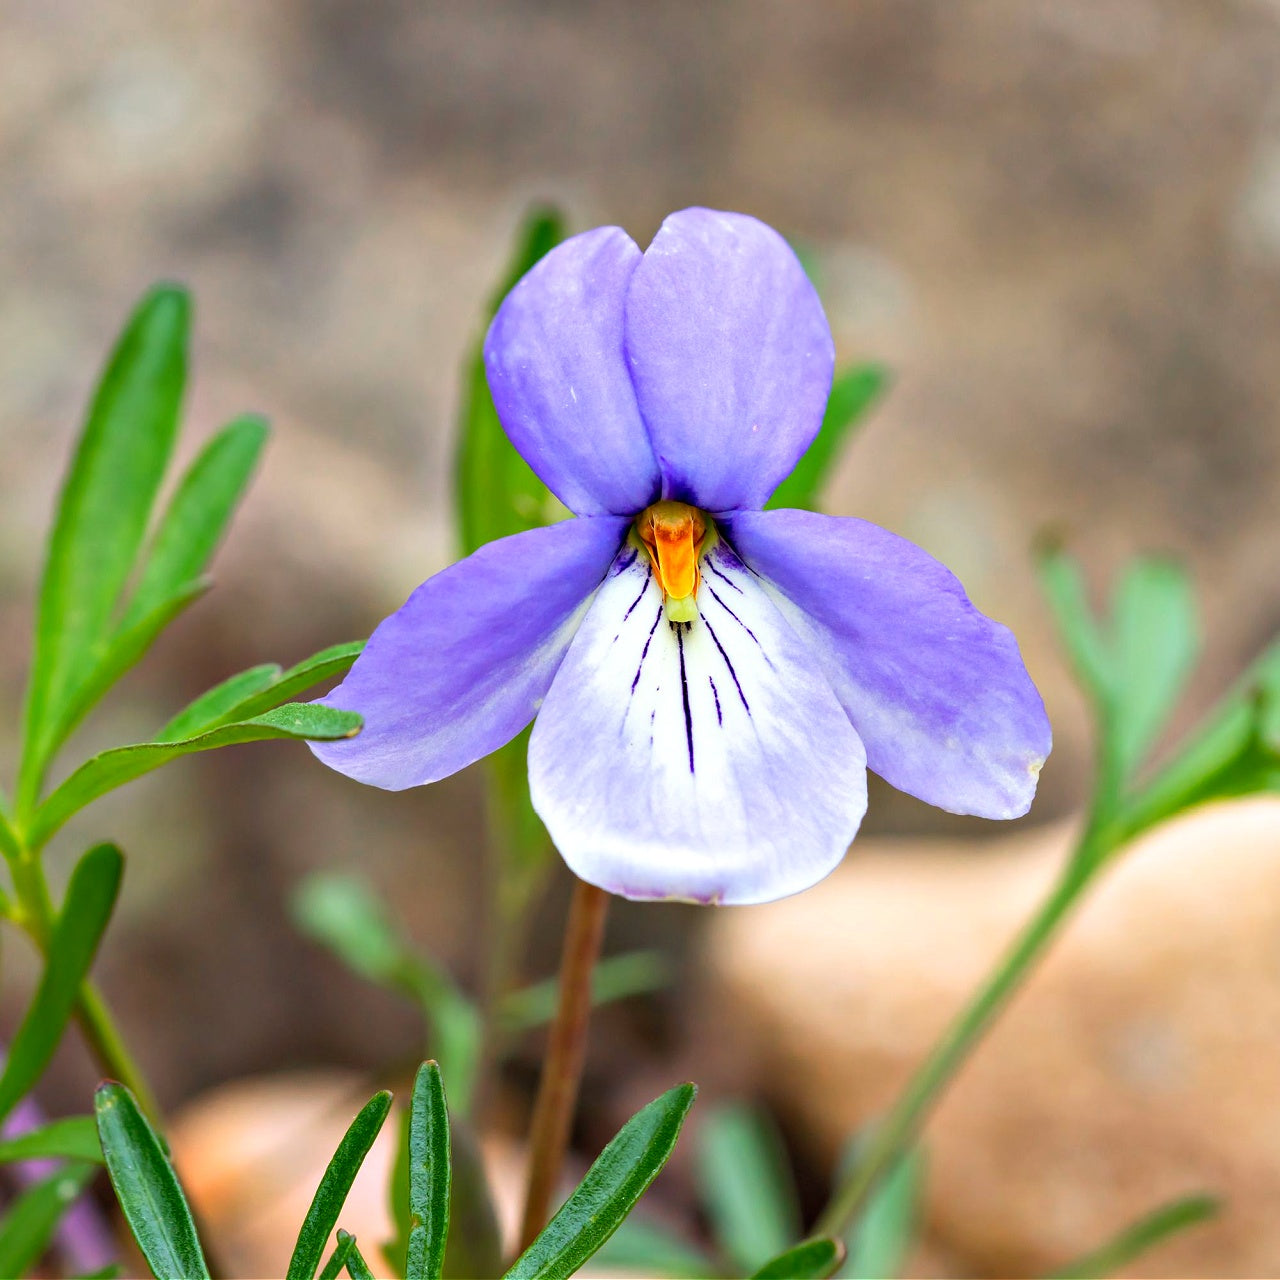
[18,287,191,812]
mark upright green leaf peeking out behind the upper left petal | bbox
[454,209,564,556]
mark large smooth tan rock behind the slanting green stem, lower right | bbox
[709,797,1280,1276]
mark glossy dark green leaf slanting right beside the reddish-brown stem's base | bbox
[507,1084,698,1280]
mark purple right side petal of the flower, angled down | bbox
[730,511,1051,818]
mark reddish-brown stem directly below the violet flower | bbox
[520,881,609,1251]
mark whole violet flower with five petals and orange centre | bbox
[311,209,1050,904]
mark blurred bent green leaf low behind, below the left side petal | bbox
[291,873,480,1115]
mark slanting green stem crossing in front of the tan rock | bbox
[814,826,1106,1236]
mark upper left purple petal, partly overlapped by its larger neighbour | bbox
[484,227,660,516]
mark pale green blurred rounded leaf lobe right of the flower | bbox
[1111,558,1199,778]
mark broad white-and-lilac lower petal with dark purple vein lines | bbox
[529,544,867,904]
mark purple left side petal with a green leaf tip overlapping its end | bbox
[311,517,627,791]
